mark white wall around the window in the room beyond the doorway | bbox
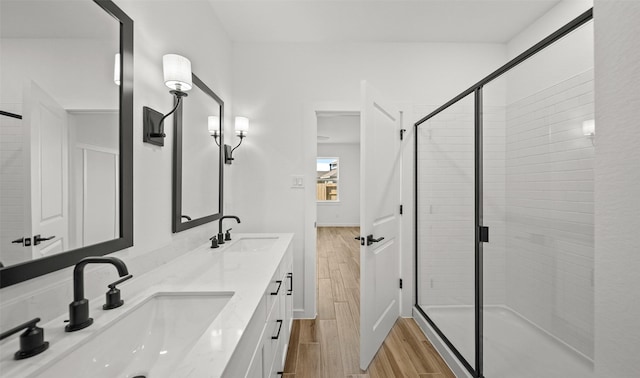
[317,143,360,227]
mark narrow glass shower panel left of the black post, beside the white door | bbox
[416,93,477,370]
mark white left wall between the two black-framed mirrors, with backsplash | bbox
[0,0,232,329]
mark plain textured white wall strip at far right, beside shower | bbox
[594,0,640,378]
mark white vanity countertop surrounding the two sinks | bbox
[0,234,293,377]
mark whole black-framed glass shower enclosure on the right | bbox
[415,10,595,378]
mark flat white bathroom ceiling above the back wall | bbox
[209,0,560,43]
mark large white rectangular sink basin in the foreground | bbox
[35,292,233,378]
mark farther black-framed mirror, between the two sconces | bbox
[172,74,224,232]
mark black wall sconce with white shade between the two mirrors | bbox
[142,54,193,146]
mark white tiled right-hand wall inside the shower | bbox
[506,70,594,358]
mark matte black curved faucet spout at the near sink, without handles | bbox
[64,257,129,332]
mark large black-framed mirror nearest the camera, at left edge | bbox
[0,0,133,288]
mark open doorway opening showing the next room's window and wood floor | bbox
[316,112,361,370]
